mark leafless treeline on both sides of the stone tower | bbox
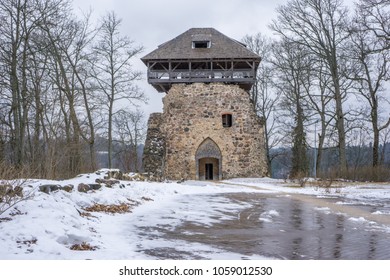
[0,0,390,182]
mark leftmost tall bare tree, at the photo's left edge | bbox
[0,0,36,167]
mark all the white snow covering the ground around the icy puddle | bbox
[0,172,390,260]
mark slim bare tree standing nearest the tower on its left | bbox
[93,12,145,168]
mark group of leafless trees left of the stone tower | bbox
[0,0,146,178]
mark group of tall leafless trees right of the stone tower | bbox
[244,0,390,177]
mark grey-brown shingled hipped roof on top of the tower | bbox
[141,28,260,64]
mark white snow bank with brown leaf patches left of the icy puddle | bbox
[0,170,262,259]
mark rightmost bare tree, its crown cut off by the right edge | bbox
[349,3,390,167]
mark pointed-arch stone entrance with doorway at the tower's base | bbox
[195,138,222,180]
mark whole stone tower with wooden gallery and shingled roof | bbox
[142,28,267,180]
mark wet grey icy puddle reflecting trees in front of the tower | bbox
[133,193,390,260]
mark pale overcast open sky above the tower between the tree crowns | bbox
[73,0,352,115]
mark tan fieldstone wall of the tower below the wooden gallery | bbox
[161,83,268,180]
